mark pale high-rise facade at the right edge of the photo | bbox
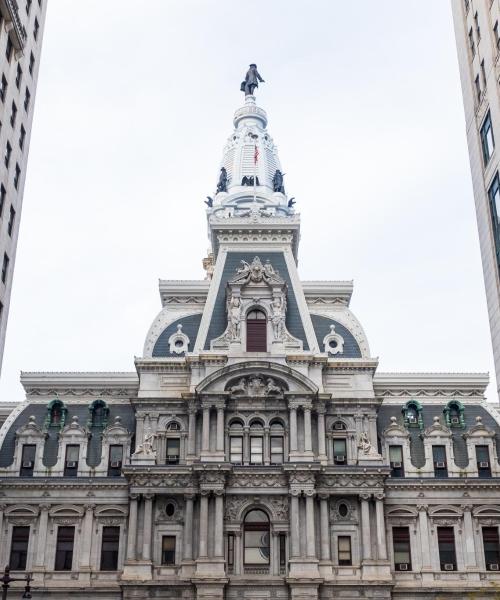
[451,0,500,400]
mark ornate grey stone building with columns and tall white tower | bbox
[0,90,500,600]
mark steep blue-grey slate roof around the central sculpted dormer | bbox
[205,251,309,350]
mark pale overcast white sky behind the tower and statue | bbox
[0,0,495,401]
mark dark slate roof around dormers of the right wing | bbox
[377,400,500,468]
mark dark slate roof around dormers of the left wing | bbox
[0,402,135,467]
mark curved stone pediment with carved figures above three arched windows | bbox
[196,361,318,397]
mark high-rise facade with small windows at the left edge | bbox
[0,0,48,369]
